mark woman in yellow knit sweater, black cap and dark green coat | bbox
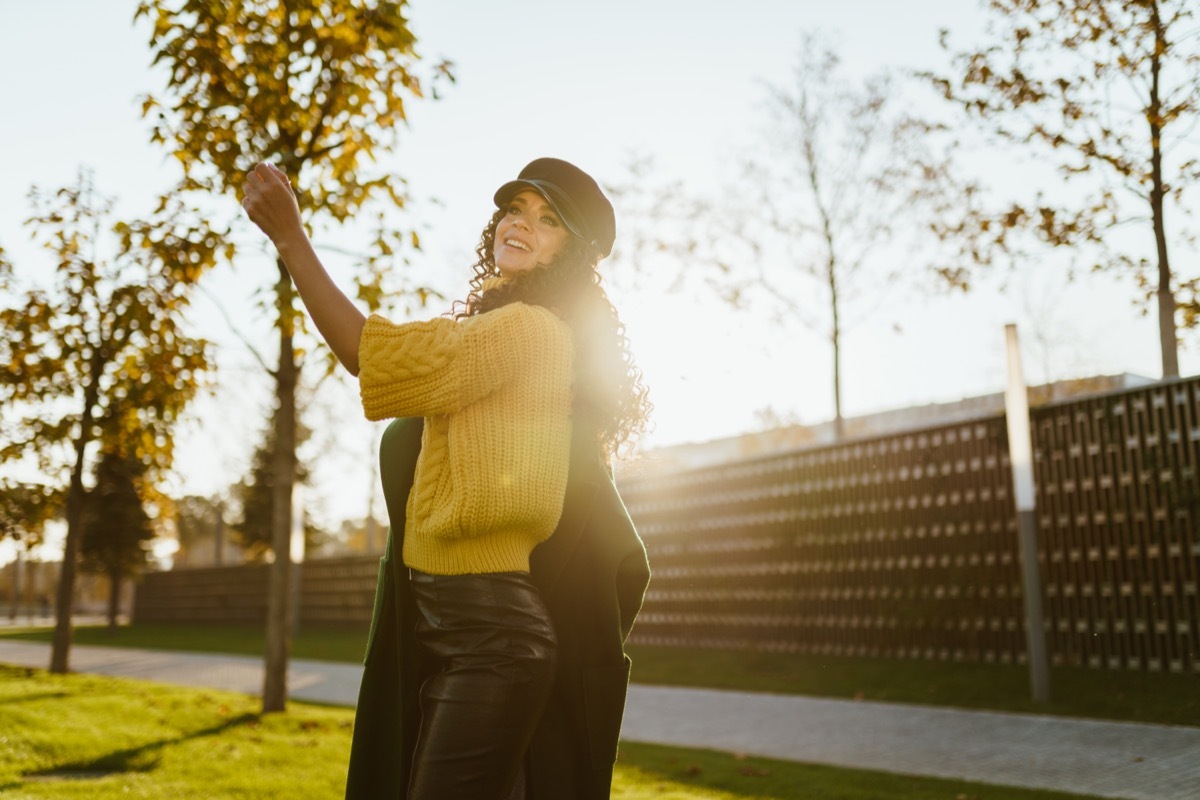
[244,158,649,800]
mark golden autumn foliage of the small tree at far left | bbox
[0,175,213,491]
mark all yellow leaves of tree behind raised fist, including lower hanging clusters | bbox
[128,0,454,400]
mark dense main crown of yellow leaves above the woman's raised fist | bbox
[145,0,432,210]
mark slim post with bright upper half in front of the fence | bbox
[1004,325,1050,703]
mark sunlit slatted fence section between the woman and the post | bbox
[625,417,1022,662]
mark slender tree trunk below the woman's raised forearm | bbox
[263,259,296,714]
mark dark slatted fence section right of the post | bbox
[1033,379,1200,672]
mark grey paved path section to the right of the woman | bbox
[622,686,1200,800]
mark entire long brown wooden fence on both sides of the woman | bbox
[134,379,1200,673]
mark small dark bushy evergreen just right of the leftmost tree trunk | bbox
[79,447,155,631]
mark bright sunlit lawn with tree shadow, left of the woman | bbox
[0,667,353,800]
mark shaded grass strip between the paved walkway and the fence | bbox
[0,625,1200,726]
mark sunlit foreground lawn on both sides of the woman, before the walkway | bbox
[0,667,1094,800]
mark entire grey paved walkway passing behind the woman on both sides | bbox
[0,639,1200,800]
